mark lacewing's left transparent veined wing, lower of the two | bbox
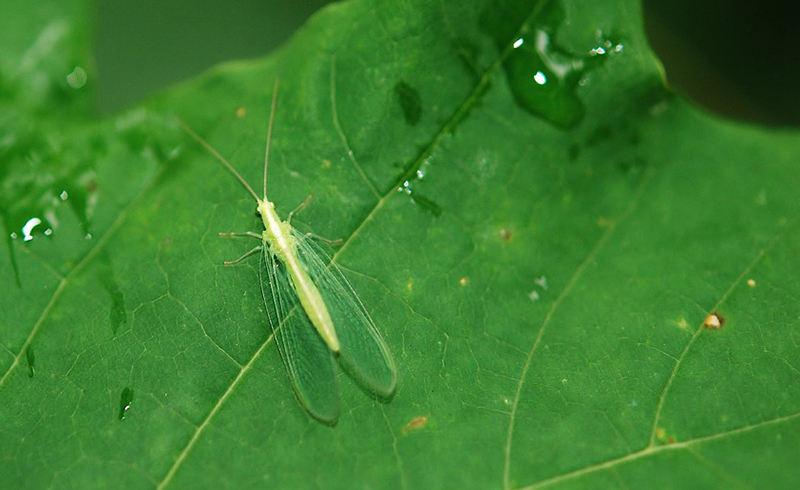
[259,246,339,423]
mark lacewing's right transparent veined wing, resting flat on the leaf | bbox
[292,230,397,398]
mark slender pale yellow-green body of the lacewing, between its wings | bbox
[258,199,339,353]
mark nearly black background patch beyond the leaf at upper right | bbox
[644,0,800,127]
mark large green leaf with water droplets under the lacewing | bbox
[0,0,800,488]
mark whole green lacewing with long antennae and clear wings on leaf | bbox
[181,79,397,424]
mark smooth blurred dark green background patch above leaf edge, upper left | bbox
[94,0,331,114]
